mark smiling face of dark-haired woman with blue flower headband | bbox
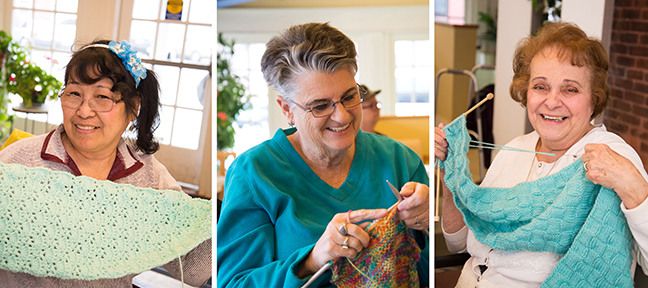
[62,78,135,157]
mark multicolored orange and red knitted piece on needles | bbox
[331,205,421,288]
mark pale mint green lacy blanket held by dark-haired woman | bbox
[0,164,211,280]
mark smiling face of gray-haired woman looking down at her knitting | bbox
[283,69,362,160]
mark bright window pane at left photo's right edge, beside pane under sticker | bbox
[184,25,213,64]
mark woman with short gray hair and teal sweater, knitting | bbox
[217,23,429,287]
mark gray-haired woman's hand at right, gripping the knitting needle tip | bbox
[398,182,430,230]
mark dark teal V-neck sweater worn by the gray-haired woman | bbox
[217,128,429,287]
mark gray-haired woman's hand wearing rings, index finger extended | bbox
[297,209,387,279]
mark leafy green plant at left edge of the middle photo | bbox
[216,33,249,150]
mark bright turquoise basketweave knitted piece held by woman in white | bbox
[441,116,633,287]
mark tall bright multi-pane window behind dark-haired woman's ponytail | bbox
[129,0,215,150]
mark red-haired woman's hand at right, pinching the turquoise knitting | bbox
[581,144,648,209]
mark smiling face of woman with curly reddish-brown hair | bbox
[527,48,593,152]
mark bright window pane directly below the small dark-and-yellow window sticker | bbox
[155,23,185,62]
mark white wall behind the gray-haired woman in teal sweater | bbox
[216,6,433,133]
